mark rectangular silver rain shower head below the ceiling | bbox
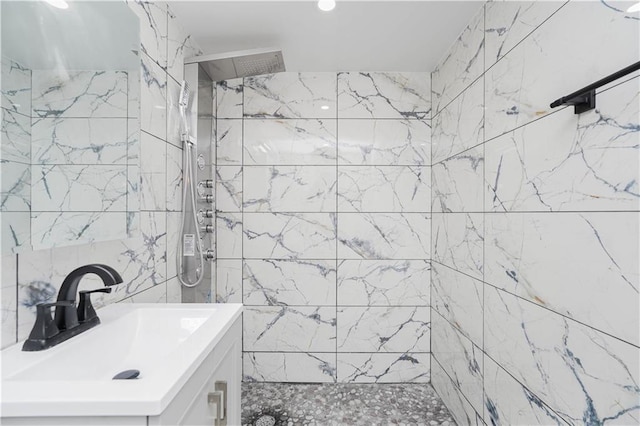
[185,48,285,81]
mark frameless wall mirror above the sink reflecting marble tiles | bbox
[0,1,140,254]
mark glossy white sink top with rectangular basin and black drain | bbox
[1,304,242,417]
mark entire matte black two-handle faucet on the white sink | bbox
[22,263,122,351]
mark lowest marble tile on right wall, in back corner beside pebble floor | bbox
[431,356,484,426]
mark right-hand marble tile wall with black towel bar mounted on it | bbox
[431,1,640,424]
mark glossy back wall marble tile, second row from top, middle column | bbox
[243,119,337,165]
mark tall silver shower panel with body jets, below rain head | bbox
[177,64,215,303]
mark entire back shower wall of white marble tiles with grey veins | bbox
[216,72,431,382]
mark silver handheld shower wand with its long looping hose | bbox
[176,81,204,288]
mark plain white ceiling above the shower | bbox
[170,0,483,71]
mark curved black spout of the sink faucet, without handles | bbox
[55,263,122,330]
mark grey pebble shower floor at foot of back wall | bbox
[242,383,456,426]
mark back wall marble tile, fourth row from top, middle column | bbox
[244,213,336,259]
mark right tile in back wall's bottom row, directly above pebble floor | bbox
[338,353,431,383]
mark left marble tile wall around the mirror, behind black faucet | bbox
[2,1,200,347]
